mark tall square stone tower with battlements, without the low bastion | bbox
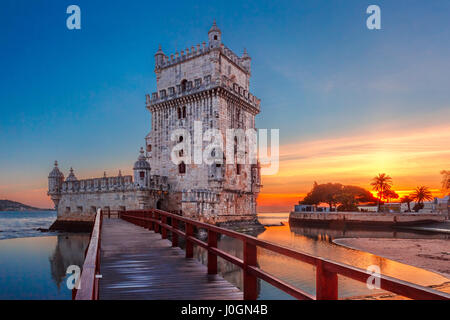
[146,22,260,223]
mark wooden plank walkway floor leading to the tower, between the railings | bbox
[99,219,243,300]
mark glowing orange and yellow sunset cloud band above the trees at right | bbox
[258,126,450,212]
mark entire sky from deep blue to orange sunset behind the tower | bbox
[0,0,450,212]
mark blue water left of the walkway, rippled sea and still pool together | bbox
[0,211,89,300]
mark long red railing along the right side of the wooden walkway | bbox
[119,209,450,300]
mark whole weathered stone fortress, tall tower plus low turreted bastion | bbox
[48,23,260,223]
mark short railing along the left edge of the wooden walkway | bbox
[72,209,103,300]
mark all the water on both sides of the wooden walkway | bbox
[0,212,449,299]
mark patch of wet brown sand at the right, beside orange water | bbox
[334,238,450,280]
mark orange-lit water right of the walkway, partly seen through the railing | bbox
[195,216,449,299]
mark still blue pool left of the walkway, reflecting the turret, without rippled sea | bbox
[0,234,89,300]
